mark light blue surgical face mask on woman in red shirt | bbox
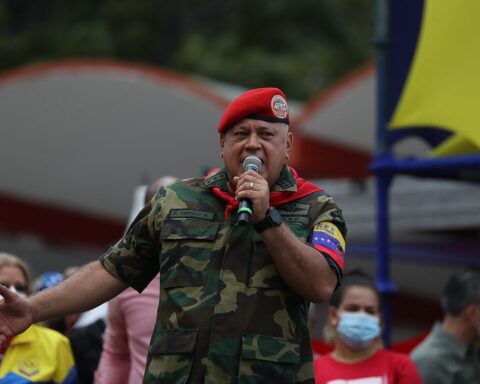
[337,312,380,349]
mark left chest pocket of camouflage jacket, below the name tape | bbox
[160,219,219,289]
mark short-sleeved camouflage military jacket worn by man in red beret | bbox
[101,167,346,384]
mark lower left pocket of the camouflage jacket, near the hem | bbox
[145,329,198,384]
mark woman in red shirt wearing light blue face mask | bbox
[315,271,422,384]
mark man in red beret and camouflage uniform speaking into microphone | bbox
[0,88,346,384]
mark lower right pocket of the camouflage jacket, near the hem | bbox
[238,335,300,384]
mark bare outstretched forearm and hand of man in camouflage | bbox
[0,261,127,342]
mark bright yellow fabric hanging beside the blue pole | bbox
[389,0,480,156]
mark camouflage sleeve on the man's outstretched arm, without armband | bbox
[100,189,165,292]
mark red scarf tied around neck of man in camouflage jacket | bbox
[208,168,322,220]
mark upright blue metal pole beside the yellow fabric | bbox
[375,0,395,348]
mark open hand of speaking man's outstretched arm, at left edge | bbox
[0,284,33,343]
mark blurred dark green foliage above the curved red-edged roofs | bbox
[0,0,374,99]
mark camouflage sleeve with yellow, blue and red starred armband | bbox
[310,195,347,286]
